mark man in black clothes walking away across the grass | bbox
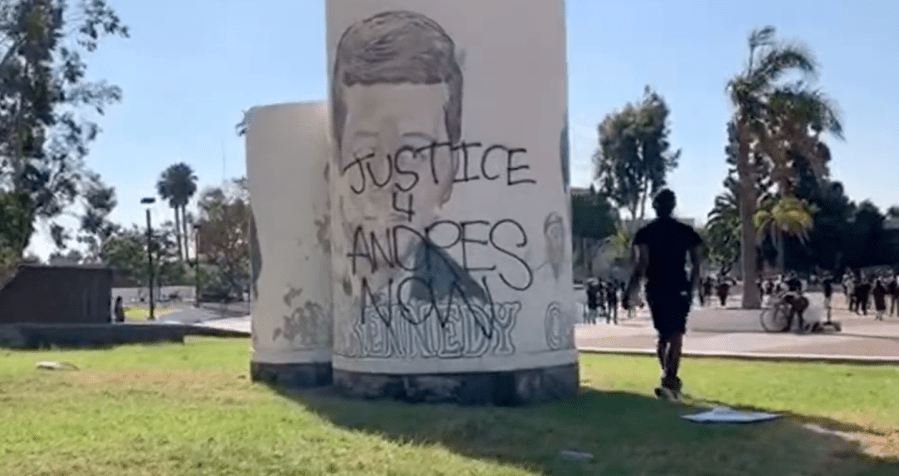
[622,189,702,399]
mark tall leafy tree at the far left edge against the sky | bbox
[0,0,128,255]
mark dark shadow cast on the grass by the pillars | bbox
[275,387,899,476]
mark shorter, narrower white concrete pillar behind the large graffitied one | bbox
[246,102,332,387]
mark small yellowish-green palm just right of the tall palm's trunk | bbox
[753,197,818,272]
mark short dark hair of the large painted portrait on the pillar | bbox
[331,11,462,152]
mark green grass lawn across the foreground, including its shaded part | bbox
[0,338,899,476]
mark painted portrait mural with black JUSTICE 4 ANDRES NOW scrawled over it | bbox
[330,11,567,359]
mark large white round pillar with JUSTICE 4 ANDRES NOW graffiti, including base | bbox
[326,0,578,405]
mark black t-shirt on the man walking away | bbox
[634,218,702,292]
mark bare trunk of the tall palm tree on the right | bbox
[737,122,762,309]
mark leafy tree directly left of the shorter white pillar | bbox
[198,179,250,300]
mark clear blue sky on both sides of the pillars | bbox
[31,0,899,257]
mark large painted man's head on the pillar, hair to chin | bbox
[331,11,462,286]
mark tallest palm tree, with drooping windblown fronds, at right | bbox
[727,26,842,309]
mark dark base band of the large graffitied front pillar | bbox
[334,362,579,406]
